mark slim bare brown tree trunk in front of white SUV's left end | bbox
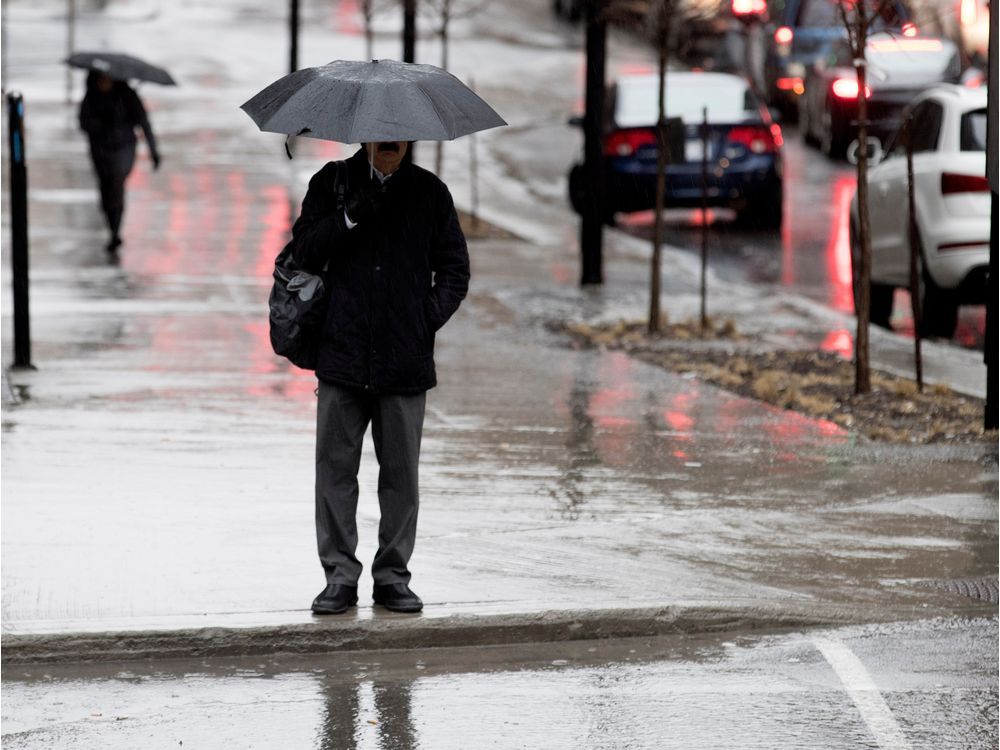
[854,0,872,394]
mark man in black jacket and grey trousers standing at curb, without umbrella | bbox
[291,141,470,614]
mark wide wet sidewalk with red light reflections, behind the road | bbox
[2,3,997,660]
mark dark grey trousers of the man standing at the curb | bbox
[316,381,427,586]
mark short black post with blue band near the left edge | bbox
[7,93,31,367]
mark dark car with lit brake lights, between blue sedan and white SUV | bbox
[800,33,961,159]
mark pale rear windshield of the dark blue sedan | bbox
[615,73,758,128]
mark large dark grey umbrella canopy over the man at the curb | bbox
[241,60,507,143]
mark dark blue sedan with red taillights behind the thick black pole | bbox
[569,71,782,229]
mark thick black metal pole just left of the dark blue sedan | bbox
[580,0,608,284]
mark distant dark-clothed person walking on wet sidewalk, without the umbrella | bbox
[80,71,160,253]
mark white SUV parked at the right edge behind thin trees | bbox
[850,84,990,338]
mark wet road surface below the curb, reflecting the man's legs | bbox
[3,618,997,750]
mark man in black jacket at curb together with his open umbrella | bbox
[242,60,506,614]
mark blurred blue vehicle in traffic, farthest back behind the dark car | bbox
[764,0,916,116]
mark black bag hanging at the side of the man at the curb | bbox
[267,162,347,370]
